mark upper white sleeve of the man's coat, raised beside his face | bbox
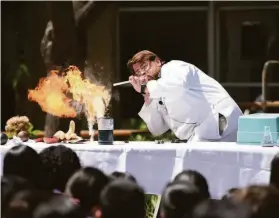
[147,61,194,98]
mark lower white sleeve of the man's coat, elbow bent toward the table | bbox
[139,100,169,136]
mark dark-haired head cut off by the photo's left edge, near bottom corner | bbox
[1,175,34,217]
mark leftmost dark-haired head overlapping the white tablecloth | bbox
[3,144,44,188]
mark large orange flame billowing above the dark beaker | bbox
[28,66,110,122]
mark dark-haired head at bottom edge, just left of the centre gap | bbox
[95,179,145,218]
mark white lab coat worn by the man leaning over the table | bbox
[139,61,242,141]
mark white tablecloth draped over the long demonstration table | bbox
[0,142,279,198]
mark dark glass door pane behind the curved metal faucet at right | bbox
[217,7,279,105]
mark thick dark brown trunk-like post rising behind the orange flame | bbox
[42,1,84,137]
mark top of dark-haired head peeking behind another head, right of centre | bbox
[174,170,210,198]
